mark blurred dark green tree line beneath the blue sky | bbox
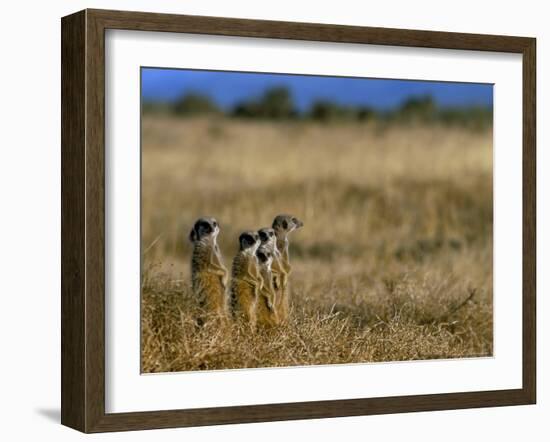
[143,87,493,129]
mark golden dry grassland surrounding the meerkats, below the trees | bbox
[141,115,493,372]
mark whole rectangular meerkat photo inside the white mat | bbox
[141,68,493,373]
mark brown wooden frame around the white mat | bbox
[61,9,536,433]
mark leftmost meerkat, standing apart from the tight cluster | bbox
[189,217,228,323]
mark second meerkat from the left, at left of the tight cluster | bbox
[231,231,263,328]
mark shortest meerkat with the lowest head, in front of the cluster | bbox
[256,245,279,327]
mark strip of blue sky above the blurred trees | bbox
[142,68,493,111]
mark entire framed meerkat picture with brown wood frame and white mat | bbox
[61,10,536,432]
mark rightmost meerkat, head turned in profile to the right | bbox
[272,215,304,322]
